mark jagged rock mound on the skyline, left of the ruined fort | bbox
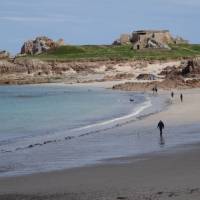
[21,36,64,55]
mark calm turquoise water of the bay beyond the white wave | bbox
[0,85,144,144]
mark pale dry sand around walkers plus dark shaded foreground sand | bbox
[0,86,200,200]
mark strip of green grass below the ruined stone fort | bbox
[25,44,200,61]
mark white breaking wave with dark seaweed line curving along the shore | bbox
[0,97,152,153]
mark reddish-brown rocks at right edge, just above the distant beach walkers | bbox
[113,58,200,91]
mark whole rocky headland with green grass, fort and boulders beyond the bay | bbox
[0,30,200,90]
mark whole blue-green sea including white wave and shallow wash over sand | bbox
[0,84,197,177]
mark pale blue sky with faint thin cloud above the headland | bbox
[0,0,200,53]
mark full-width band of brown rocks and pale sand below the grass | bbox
[0,58,200,90]
